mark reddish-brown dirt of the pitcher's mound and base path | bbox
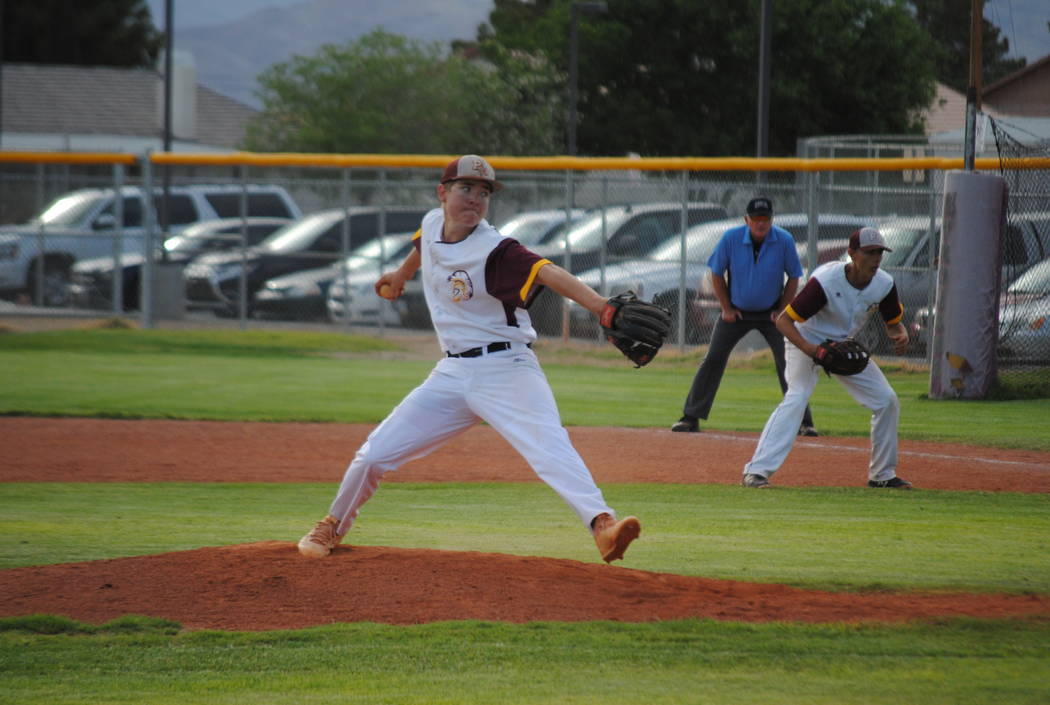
[0,417,1050,630]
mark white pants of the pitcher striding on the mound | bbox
[329,344,615,535]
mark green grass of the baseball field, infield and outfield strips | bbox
[0,330,1050,704]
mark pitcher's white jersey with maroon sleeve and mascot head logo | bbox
[416,209,550,352]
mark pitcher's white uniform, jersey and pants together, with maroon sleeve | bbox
[329,210,615,535]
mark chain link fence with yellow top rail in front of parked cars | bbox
[0,149,1050,390]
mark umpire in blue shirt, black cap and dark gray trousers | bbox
[671,196,817,436]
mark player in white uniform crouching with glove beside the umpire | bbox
[742,228,911,490]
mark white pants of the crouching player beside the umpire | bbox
[743,344,901,482]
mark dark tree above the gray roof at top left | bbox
[0,0,163,67]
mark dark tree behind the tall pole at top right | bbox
[910,0,1026,92]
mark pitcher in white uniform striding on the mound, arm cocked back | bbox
[299,154,651,562]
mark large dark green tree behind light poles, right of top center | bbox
[479,0,935,157]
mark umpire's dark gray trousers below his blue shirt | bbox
[683,311,814,426]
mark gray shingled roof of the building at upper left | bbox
[0,64,256,151]
